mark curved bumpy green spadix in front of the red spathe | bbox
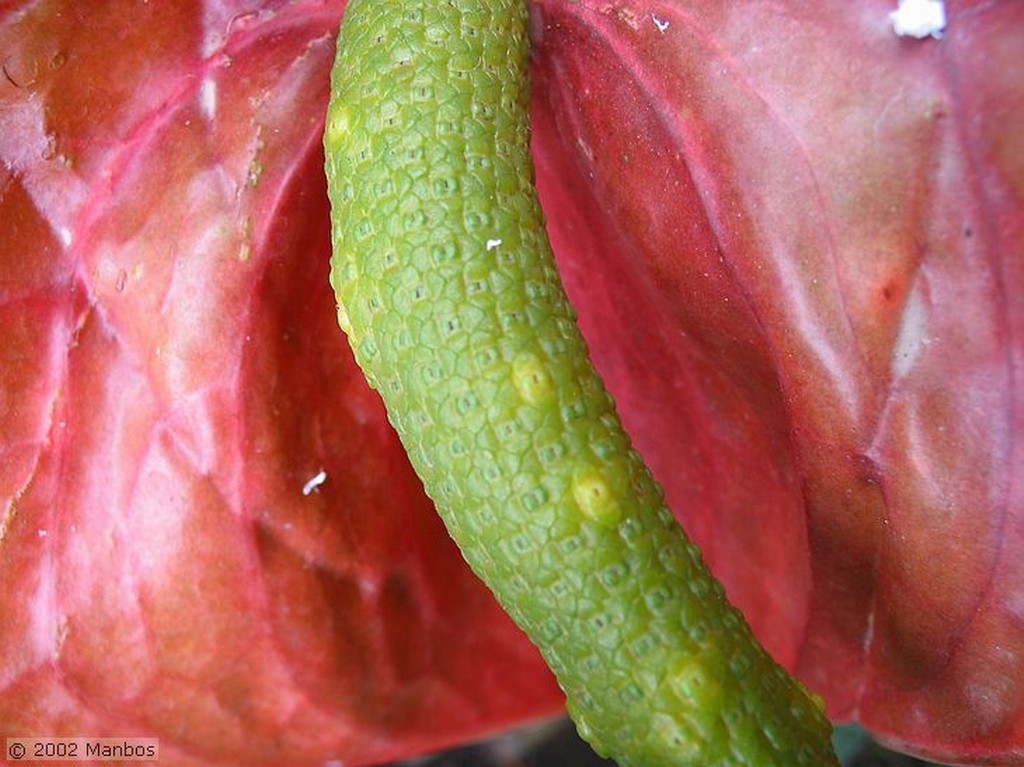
[325,0,837,767]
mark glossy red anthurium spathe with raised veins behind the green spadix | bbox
[0,0,1024,765]
